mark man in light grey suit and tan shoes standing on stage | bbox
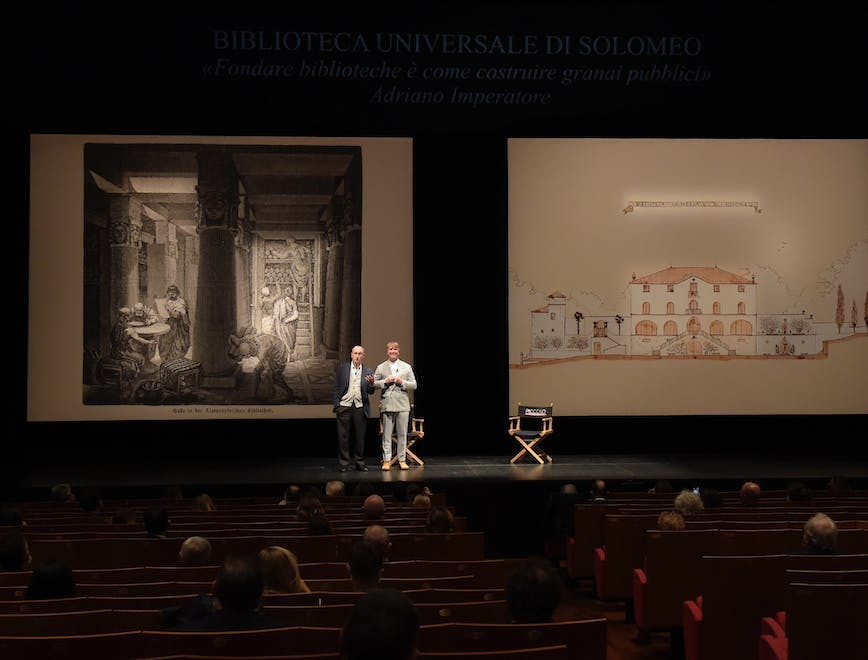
[374,341,416,470]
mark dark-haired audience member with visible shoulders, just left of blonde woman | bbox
[171,555,283,632]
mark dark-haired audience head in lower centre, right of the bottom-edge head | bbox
[506,557,563,623]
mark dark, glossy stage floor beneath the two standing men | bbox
[7,454,868,488]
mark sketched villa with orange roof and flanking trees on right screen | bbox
[522,266,868,363]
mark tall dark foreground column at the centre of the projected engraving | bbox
[193,150,238,376]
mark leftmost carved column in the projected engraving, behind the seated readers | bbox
[109,195,142,319]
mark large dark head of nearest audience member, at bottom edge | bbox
[340,589,419,660]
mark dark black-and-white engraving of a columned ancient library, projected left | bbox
[83,143,362,405]
